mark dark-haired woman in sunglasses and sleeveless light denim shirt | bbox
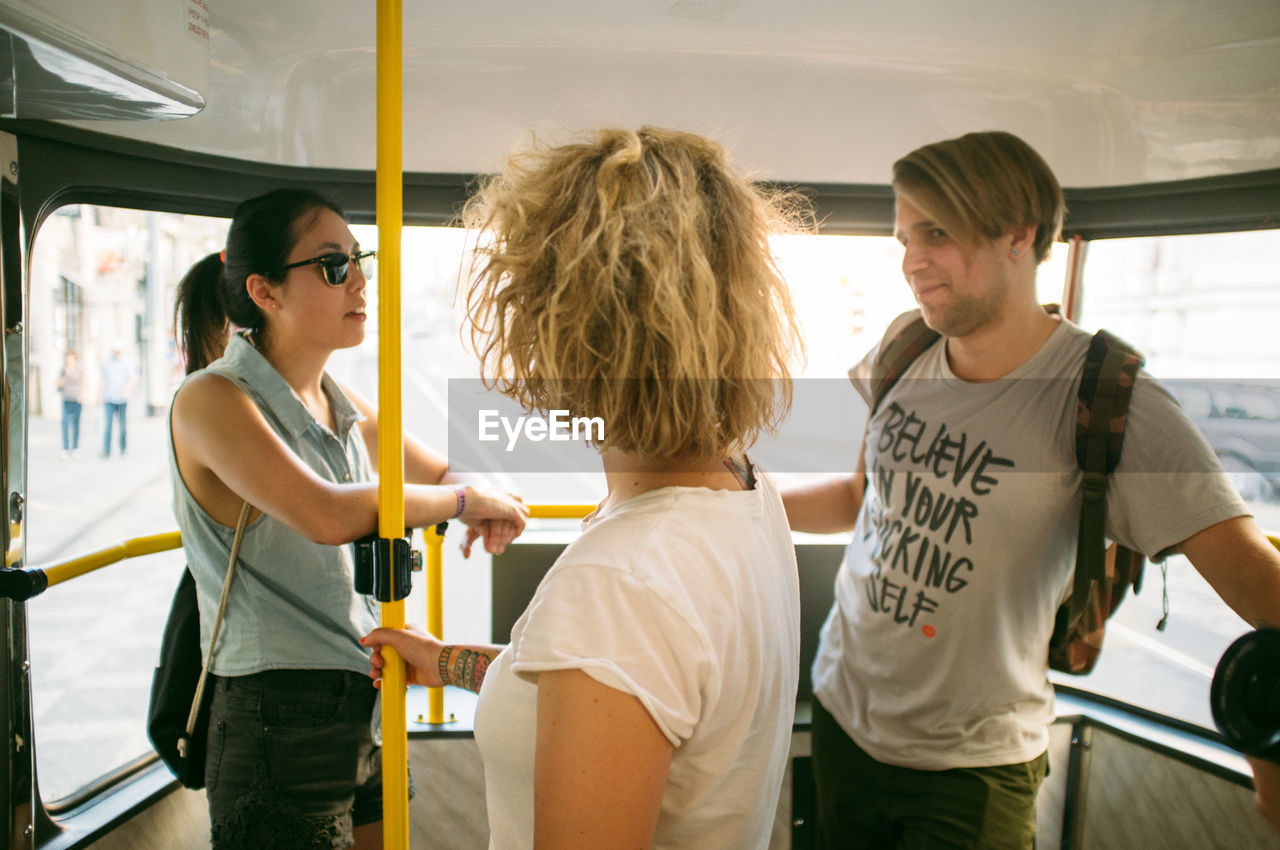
[170,189,527,849]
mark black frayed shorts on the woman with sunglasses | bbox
[205,670,404,850]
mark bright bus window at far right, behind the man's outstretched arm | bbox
[1060,230,1280,728]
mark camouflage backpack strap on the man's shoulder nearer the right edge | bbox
[1071,330,1143,620]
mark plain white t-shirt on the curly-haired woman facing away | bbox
[476,475,800,850]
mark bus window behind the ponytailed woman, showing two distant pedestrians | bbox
[27,206,227,803]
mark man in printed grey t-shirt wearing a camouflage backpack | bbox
[783,132,1280,847]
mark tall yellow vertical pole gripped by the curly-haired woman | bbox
[376,0,408,850]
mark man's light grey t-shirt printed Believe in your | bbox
[813,317,1248,771]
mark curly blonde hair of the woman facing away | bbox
[463,127,812,460]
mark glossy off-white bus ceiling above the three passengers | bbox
[0,0,1280,238]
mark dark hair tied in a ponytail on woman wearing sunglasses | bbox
[174,189,346,374]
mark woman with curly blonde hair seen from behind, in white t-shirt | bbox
[366,128,800,850]
